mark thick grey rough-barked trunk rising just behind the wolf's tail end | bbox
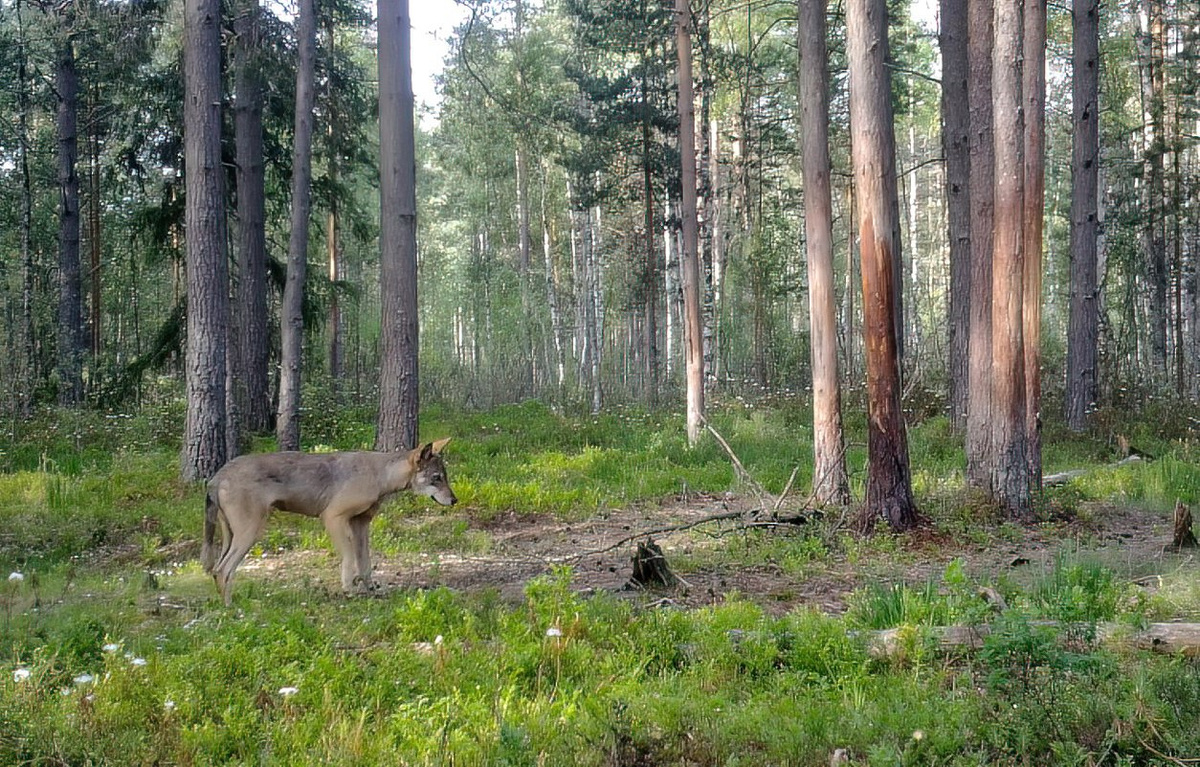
[181,0,229,481]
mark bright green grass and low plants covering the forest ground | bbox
[0,401,1200,766]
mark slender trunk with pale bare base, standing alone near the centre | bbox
[676,0,704,447]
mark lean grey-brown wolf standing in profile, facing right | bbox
[200,437,458,605]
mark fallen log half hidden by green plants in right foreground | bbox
[866,621,1200,659]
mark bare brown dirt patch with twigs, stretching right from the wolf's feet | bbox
[234,493,1200,615]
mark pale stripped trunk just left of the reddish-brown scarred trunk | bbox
[797,0,850,505]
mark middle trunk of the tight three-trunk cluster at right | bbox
[991,0,1032,519]
